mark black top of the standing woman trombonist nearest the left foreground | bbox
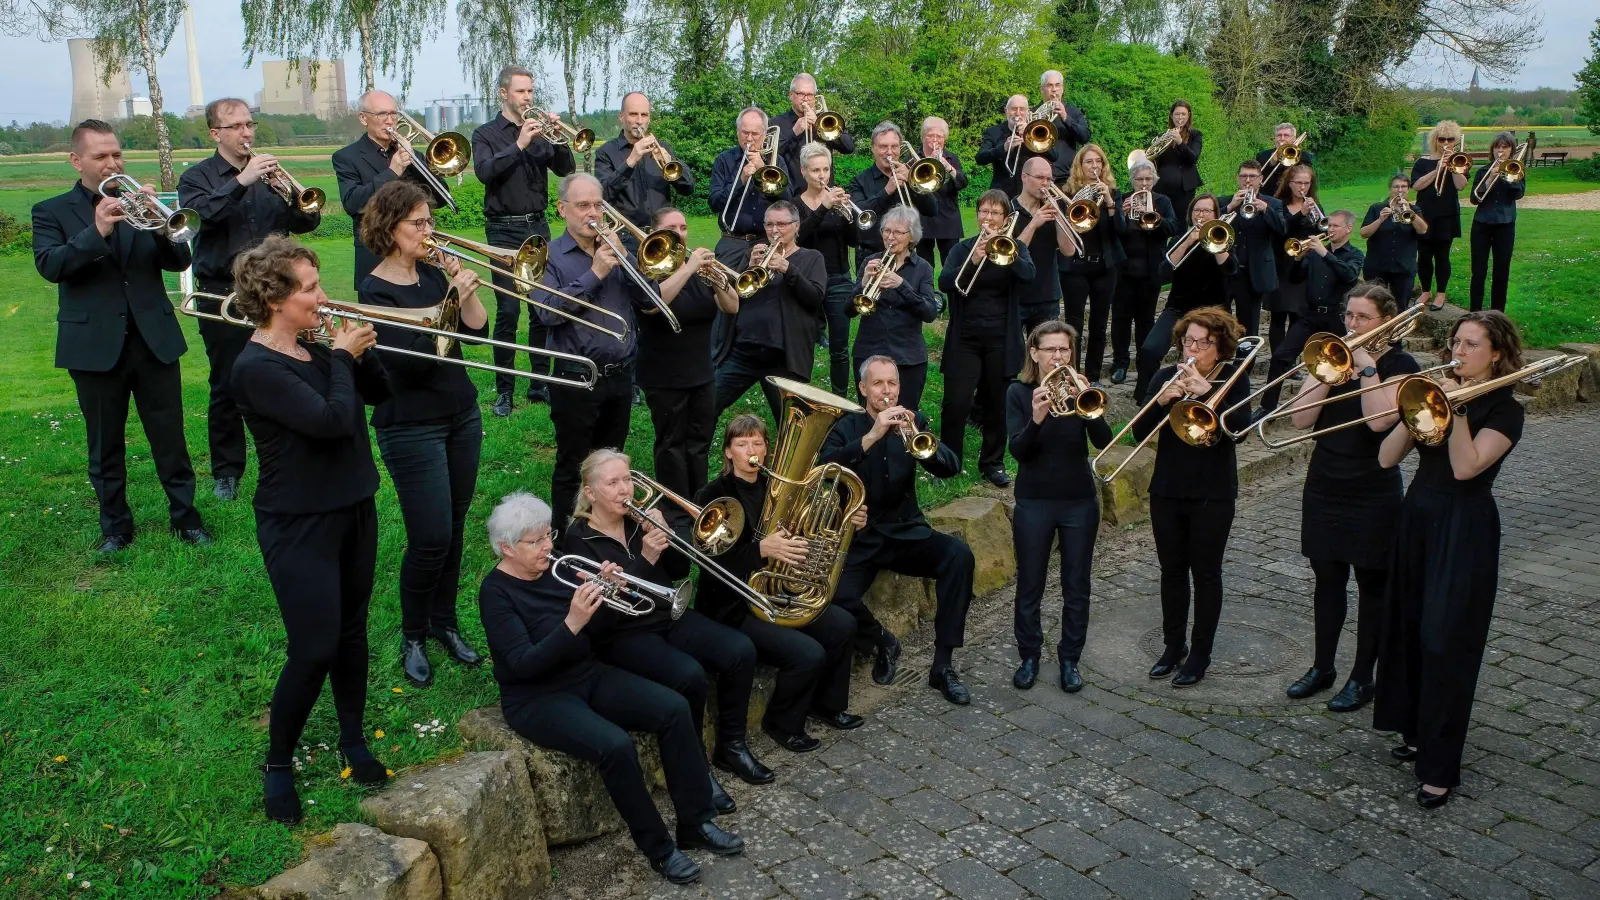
[229,341,389,516]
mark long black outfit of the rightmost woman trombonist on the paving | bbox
[1373,386,1523,788]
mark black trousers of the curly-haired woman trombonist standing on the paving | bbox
[1150,496,1234,666]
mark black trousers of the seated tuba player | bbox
[739,604,856,735]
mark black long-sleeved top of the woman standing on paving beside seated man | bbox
[1005,381,1112,500]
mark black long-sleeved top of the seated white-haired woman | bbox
[478,569,605,709]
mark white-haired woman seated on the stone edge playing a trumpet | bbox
[478,493,744,884]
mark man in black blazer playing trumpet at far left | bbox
[34,119,211,552]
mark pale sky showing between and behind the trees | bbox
[0,0,1597,123]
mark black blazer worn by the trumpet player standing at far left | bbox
[34,184,190,372]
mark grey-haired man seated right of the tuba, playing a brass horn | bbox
[819,356,972,706]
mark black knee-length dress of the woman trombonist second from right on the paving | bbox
[1301,348,1421,569]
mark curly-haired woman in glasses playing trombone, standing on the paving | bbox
[1133,304,1250,687]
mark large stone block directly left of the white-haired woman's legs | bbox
[362,751,550,900]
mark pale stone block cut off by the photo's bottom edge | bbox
[244,822,443,900]
